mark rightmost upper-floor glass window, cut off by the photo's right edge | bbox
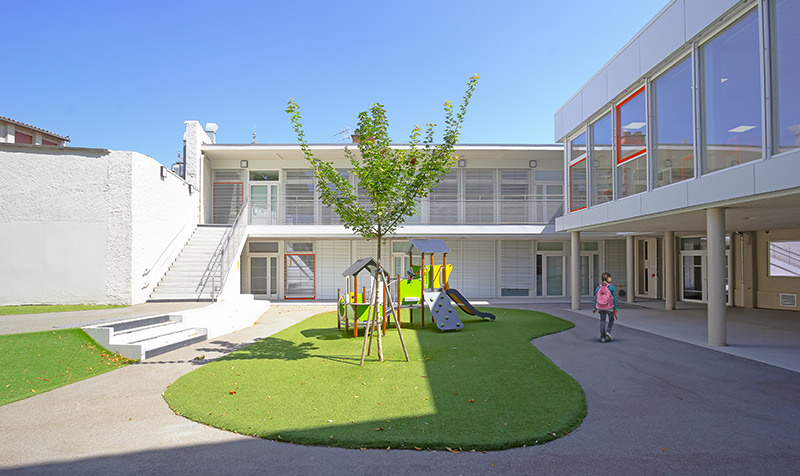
[772,0,800,152]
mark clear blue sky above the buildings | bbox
[6,0,667,165]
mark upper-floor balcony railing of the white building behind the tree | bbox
[250,195,564,225]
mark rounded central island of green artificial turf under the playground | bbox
[164,309,586,451]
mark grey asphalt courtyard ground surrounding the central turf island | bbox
[0,303,800,475]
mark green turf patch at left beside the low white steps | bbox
[0,329,132,405]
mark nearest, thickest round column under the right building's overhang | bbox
[706,208,727,345]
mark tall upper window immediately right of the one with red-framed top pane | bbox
[651,56,694,187]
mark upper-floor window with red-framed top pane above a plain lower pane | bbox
[617,86,647,197]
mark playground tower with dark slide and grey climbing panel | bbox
[397,239,495,331]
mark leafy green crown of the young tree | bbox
[286,74,479,266]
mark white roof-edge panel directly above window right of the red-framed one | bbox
[639,0,686,72]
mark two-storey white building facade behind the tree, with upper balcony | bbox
[186,126,569,300]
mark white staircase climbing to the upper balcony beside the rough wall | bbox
[149,225,230,302]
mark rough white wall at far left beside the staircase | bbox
[0,144,198,305]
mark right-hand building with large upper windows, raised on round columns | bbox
[555,0,800,345]
